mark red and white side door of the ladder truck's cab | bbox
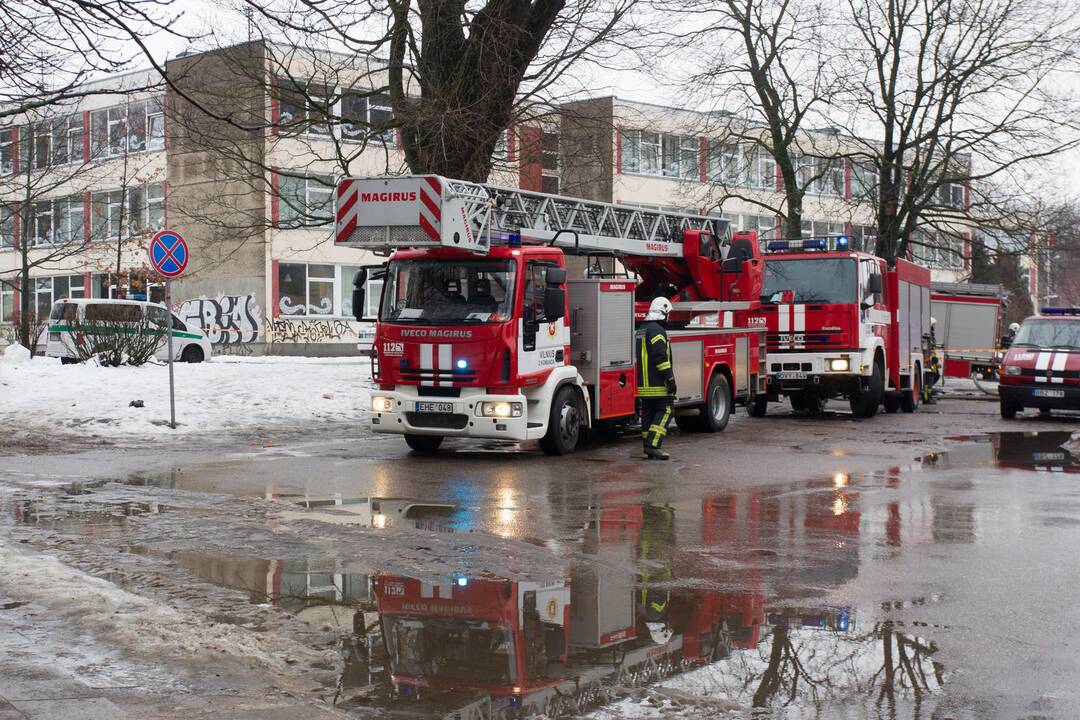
[517,260,570,375]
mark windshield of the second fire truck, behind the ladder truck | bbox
[761,258,859,304]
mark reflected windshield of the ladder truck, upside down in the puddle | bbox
[382,615,517,685]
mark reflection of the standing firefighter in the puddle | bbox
[637,502,675,643]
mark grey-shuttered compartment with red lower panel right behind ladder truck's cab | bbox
[567,279,637,419]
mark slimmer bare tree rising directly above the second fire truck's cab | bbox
[661,0,843,239]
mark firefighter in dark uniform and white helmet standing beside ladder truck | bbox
[636,298,675,460]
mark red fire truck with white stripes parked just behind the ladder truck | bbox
[748,236,930,418]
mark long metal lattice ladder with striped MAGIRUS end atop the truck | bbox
[336,175,731,257]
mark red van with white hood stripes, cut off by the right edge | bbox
[998,308,1080,420]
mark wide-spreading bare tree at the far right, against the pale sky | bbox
[842,0,1078,260]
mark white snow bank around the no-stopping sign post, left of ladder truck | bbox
[0,356,372,439]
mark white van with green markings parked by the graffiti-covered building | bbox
[45,298,211,363]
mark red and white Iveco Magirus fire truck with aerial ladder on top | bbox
[336,175,765,454]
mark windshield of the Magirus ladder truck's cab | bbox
[379,259,515,325]
